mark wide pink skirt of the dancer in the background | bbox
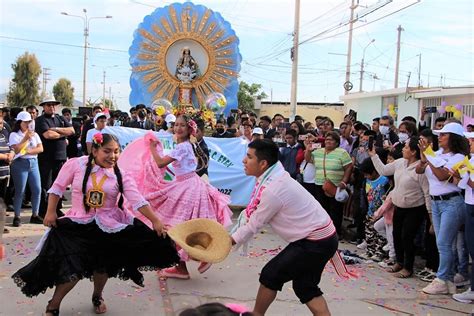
[137,172,232,227]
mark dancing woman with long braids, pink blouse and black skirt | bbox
[12,133,179,316]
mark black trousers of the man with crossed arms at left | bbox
[38,158,65,217]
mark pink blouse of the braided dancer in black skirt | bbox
[48,156,149,233]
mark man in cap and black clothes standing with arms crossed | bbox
[35,97,74,217]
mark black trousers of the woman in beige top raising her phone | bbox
[393,205,427,271]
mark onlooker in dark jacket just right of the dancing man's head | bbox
[278,129,304,179]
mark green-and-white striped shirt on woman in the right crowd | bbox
[312,148,352,185]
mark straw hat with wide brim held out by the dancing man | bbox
[168,218,232,263]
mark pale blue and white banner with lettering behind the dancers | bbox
[104,126,255,206]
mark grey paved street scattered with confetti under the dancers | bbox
[0,201,474,315]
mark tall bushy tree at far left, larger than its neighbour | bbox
[7,52,41,107]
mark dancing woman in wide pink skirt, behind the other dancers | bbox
[131,115,232,279]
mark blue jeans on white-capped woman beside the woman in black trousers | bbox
[431,195,465,281]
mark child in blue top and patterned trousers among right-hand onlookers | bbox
[360,158,389,261]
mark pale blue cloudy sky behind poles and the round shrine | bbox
[0,0,474,110]
